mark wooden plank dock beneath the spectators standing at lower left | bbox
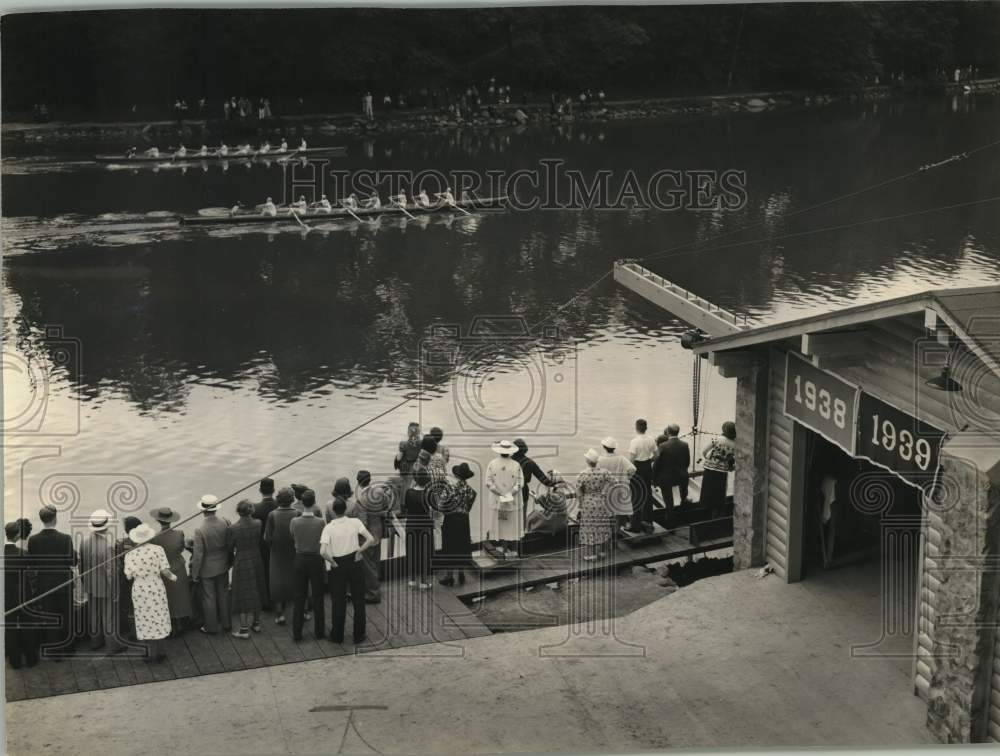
[5,578,491,702]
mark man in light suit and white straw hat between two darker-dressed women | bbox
[191,494,233,635]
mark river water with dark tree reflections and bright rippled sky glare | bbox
[3,98,1000,535]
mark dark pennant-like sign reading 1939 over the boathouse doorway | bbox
[856,392,946,490]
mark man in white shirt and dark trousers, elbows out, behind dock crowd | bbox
[319,497,375,645]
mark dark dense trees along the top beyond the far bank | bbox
[2,2,1000,111]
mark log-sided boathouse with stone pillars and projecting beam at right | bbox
[615,263,1000,743]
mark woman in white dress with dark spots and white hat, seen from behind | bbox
[125,523,177,662]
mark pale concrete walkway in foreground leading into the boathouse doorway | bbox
[6,566,932,756]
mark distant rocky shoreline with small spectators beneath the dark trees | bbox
[0,77,1000,145]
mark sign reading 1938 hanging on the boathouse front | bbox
[785,352,859,457]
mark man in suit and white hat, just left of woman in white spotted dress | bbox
[80,509,125,654]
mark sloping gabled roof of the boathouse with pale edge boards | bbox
[694,284,1000,375]
